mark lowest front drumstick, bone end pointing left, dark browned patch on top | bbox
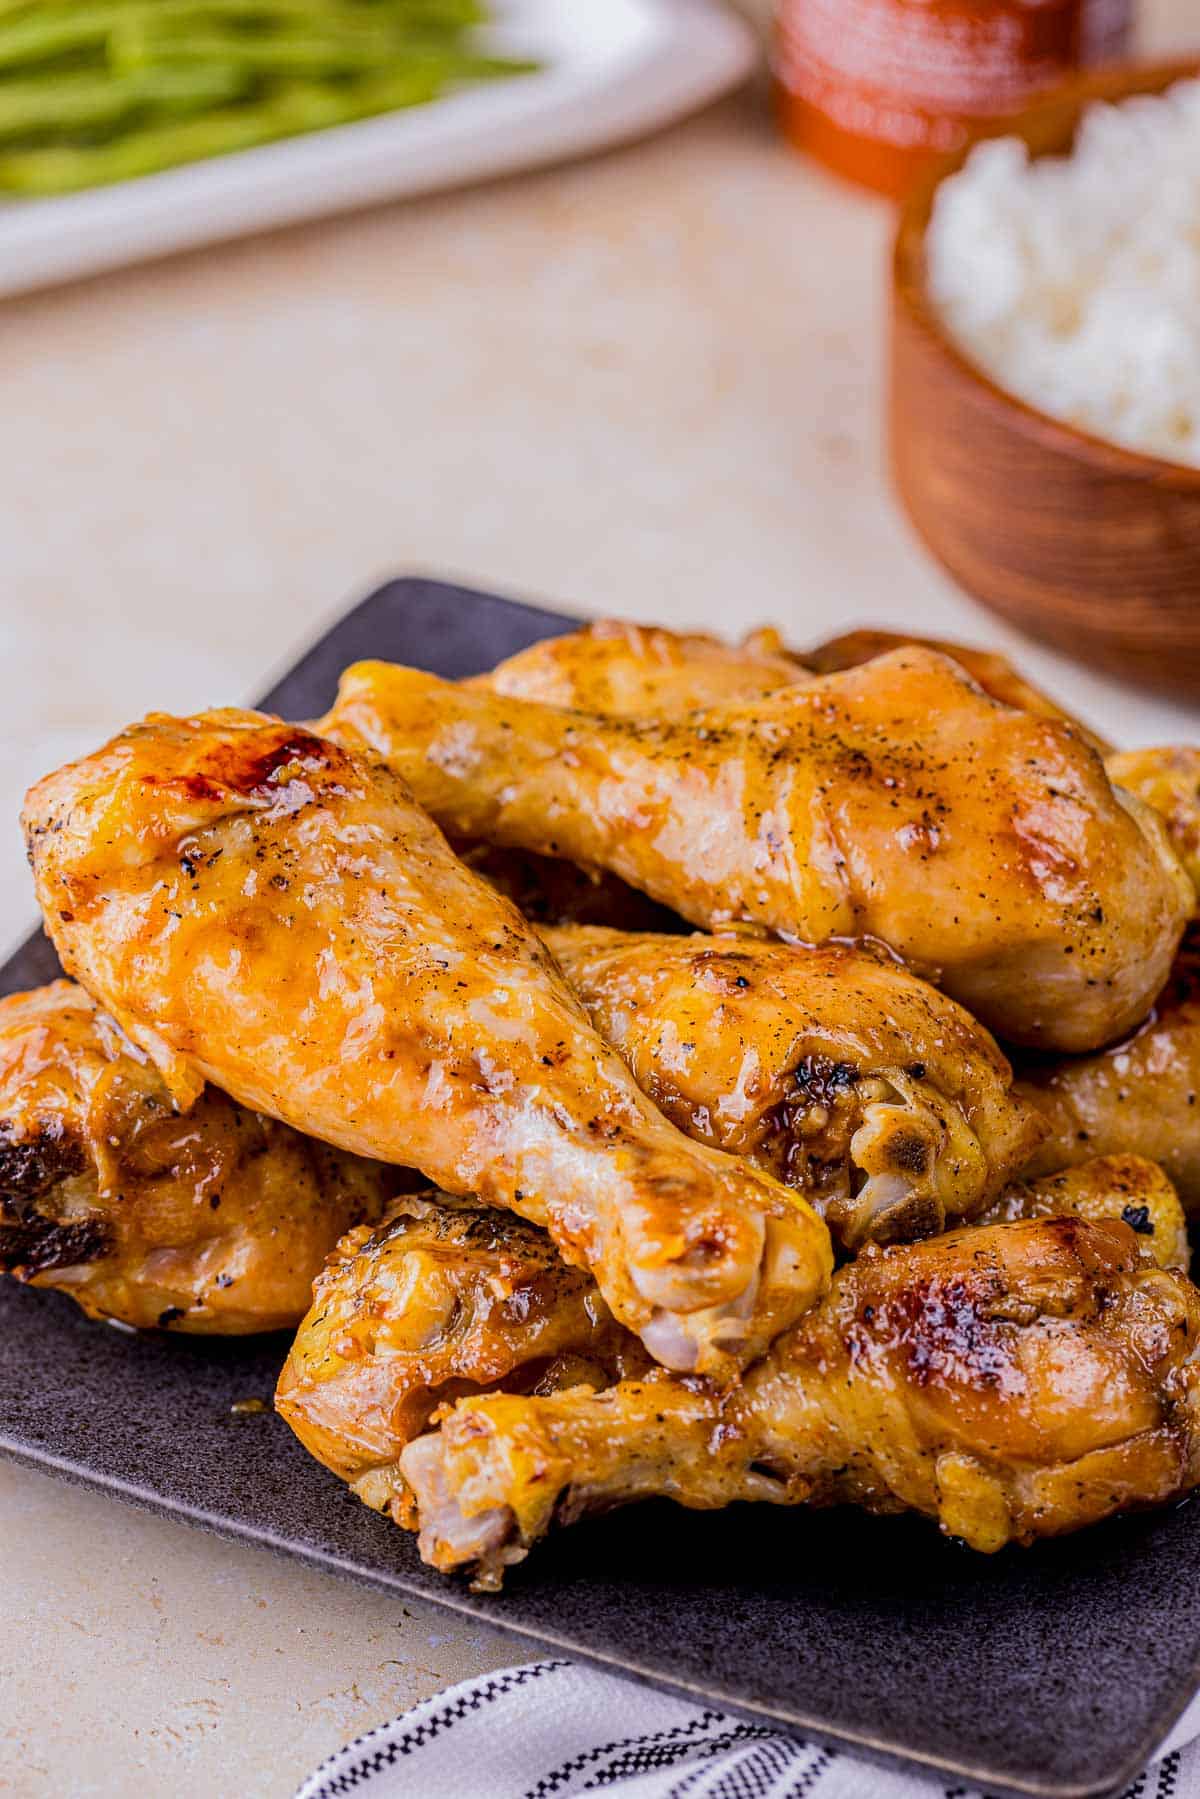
[399,1218,1200,1585]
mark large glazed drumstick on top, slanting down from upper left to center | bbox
[23,711,831,1376]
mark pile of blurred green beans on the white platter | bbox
[0,0,536,196]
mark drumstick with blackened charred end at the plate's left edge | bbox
[0,980,401,1333]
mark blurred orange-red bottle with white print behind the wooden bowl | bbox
[775,0,1132,194]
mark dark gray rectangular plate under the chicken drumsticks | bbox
[0,581,1200,1799]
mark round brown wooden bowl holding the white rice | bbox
[889,58,1200,698]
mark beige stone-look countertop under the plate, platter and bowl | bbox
[0,0,1200,1799]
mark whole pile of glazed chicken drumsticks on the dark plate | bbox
[0,624,1200,1587]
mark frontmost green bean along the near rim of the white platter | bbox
[0,65,532,196]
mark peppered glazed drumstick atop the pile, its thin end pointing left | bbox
[326,649,1193,1051]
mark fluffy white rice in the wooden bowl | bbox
[927,81,1200,466]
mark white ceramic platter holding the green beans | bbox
[0,0,754,293]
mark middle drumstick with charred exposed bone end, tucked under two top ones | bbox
[542,926,1043,1247]
